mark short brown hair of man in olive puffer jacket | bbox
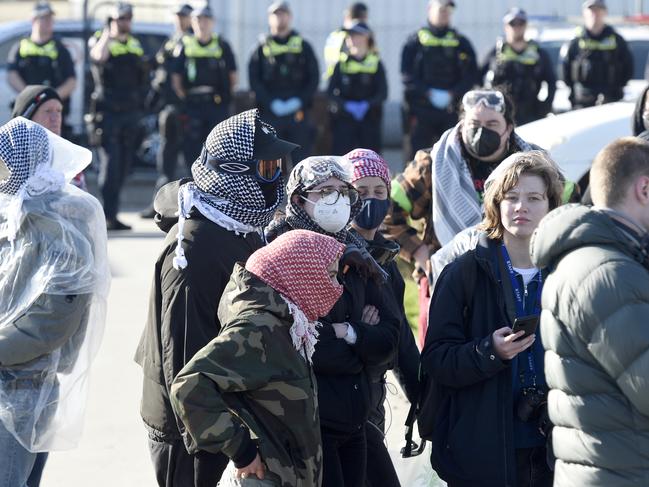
[590,137,649,207]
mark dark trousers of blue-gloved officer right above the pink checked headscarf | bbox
[331,114,383,156]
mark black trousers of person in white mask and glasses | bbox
[320,427,367,487]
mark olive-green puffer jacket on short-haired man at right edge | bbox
[532,205,649,487]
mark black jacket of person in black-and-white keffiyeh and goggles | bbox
[135,181,263,442]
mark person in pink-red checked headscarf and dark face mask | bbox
[344,149,419,487]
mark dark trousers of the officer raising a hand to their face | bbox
[98,111,140,219]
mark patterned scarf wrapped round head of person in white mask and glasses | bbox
[278,156,364,247]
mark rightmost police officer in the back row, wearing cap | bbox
[561,0,633,108]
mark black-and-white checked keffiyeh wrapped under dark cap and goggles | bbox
[174,109,284,269]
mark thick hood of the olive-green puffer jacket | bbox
[530,204,645,268]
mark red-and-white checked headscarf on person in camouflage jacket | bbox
[246,230,345,321]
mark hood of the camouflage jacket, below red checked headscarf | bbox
[218,262,293,328]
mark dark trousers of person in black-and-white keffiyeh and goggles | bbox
[149,438,229,487]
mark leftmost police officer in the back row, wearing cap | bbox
[7,2,77,135]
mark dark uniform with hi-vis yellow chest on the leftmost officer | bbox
[7,37,76,130]
